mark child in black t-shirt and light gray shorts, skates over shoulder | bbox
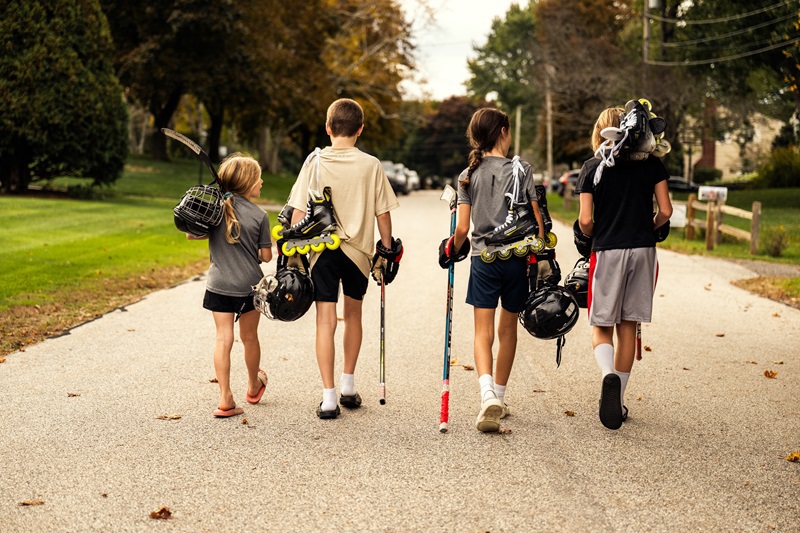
[574,108,672,429]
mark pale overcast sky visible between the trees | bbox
[400,0,527,100]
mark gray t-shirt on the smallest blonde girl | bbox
[206,194,272,296]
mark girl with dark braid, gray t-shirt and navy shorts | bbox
[440,108,545,432]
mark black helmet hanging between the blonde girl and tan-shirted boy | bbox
[253,267,314,322]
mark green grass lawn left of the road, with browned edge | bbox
[0,157,294,355]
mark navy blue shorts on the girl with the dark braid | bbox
[467,255,528,313]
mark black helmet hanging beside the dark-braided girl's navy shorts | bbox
[519,283,578,339]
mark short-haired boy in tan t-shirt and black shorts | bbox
[288,98,403,419]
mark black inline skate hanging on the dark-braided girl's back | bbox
[481,193,545,263]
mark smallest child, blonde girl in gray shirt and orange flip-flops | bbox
[186,153,272,418]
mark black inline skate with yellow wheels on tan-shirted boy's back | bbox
[272,187,341,257]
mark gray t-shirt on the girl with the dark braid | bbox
[458,156,538,255]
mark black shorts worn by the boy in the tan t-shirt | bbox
[311,248,369,302]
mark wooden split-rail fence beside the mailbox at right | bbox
[686,193,761,255]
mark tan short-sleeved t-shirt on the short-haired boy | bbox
[287,146,399,276]
